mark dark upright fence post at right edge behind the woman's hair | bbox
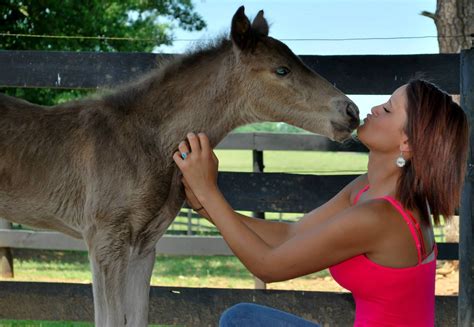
[460,48,474,327]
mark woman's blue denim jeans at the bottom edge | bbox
[219,303,319,327]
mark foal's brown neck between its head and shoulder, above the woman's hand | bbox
[135,50,246,158]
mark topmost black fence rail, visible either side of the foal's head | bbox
[0,51,460,94]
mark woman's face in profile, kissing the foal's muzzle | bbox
[357,85,408,154]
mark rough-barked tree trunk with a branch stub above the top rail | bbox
[421,0,474,53]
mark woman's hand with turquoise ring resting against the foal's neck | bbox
[173,133,219,203]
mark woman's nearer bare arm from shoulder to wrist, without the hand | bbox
[203,190,386,283]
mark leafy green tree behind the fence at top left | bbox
[0,0,206,104]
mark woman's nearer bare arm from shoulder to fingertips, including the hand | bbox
[173,134,383,282]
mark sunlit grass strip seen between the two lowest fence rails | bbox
[7,249,327,288]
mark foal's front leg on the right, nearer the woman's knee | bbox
[125,247,155,327]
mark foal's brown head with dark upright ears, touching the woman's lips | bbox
[231,6,359,141]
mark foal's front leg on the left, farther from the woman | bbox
[84,226,130,327]
